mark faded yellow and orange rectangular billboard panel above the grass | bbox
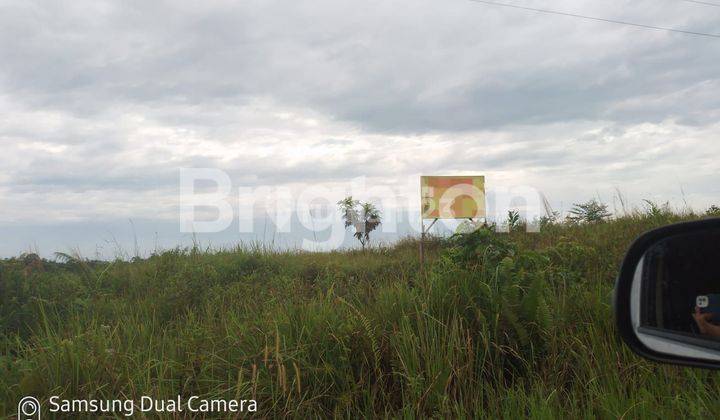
[420,175,485,219]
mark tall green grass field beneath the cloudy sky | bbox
[0,213,720,419]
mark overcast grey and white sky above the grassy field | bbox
[0,0,720,257]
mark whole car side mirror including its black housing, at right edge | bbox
[613,219,720,369]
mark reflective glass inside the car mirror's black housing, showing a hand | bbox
[631,230,720,360]
